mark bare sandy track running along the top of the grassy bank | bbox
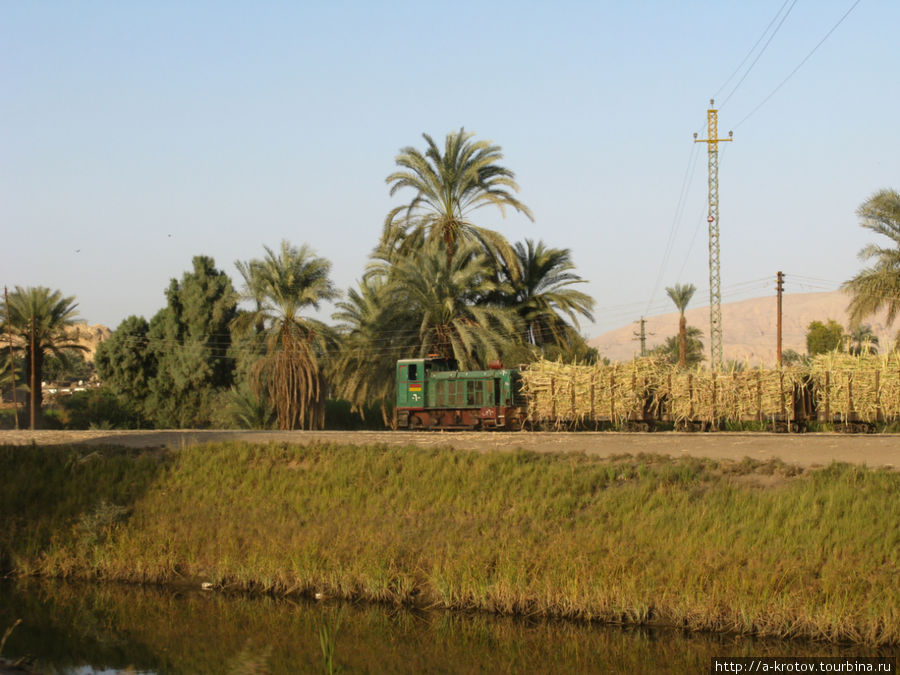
[0,431,900,468]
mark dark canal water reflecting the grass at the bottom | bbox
[0,581,897,675]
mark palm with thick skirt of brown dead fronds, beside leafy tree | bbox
[235,241,339,430]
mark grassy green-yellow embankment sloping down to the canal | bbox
[0,444,900,645]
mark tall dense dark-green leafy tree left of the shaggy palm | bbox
[145,256,237,428]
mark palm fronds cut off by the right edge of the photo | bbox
[842,190,900,326]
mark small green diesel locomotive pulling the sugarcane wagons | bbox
[396,357,527,430]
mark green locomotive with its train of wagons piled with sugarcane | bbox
[395,356,900,432]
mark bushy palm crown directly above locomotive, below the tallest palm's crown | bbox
[370,242,519,370]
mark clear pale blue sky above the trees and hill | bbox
[0,0,900,341]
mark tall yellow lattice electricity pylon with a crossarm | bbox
[694,99,734,370]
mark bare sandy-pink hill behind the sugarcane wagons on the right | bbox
[588,291,900,365]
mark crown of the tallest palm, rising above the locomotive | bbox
[382,129,533,270]
